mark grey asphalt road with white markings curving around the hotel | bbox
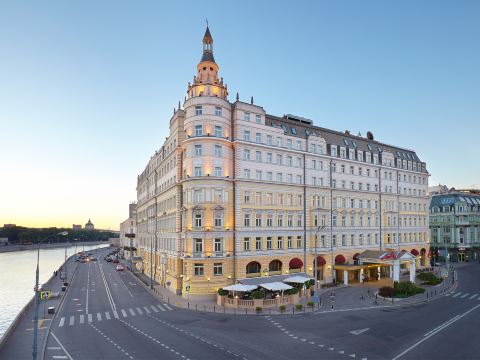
[41,250,480,360]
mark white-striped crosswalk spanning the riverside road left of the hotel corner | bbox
[58,303,174,327]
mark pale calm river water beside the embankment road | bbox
[0,244,108,338]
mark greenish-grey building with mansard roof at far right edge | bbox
[430,190,480,262]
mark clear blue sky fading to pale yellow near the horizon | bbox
[0,0,480,229]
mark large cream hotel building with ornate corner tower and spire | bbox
[136,27,429,297]
